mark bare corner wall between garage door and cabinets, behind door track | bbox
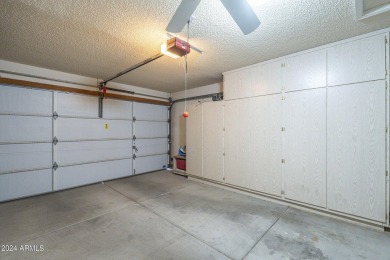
[171,82,223,160]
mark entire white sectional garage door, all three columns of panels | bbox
[0,85,168,201]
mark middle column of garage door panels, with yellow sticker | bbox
[53,93,133,190]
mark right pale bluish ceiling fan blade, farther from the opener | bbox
[221,0,260,35]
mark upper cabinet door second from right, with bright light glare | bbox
[282,50,326,92]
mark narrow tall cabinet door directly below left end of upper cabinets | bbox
[224,98,252,188]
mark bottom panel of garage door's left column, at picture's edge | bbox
[0,169,52,201]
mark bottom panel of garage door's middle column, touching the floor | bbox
[55,159,133,190]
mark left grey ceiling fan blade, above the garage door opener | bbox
[165,0,201,33]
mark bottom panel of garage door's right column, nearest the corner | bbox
[134,154,168,174]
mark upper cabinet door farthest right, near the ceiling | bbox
[327,34,386,86]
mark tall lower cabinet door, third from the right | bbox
[250,94,282,196]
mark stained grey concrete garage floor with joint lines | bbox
[0,171,390,259]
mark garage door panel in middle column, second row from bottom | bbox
[56,140,133,166]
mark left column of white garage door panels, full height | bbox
[0,85,53,201]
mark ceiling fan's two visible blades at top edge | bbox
[165,0,260,35]
